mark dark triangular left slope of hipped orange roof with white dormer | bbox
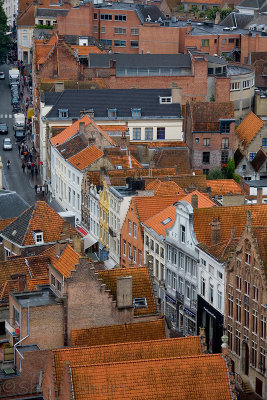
[0,205,35,245]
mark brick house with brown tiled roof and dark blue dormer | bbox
[185,102,235,174]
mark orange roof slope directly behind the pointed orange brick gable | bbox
[134,195,179,222]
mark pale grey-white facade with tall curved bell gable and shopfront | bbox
[165,201,198,336]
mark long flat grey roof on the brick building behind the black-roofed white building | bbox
[89,54,191,68]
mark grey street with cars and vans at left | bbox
[0,65,36,205]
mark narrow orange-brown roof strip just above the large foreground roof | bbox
[72,318,166,347]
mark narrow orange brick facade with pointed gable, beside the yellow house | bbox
[121,201,144,267]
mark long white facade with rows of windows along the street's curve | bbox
[51,146,83,222]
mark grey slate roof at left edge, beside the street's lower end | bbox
[0,189,29,219]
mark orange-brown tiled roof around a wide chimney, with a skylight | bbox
[97,267,156,315]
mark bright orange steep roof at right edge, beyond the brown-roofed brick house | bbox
[236,111,264,148]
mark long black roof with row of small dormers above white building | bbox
[46,89,181,120]
